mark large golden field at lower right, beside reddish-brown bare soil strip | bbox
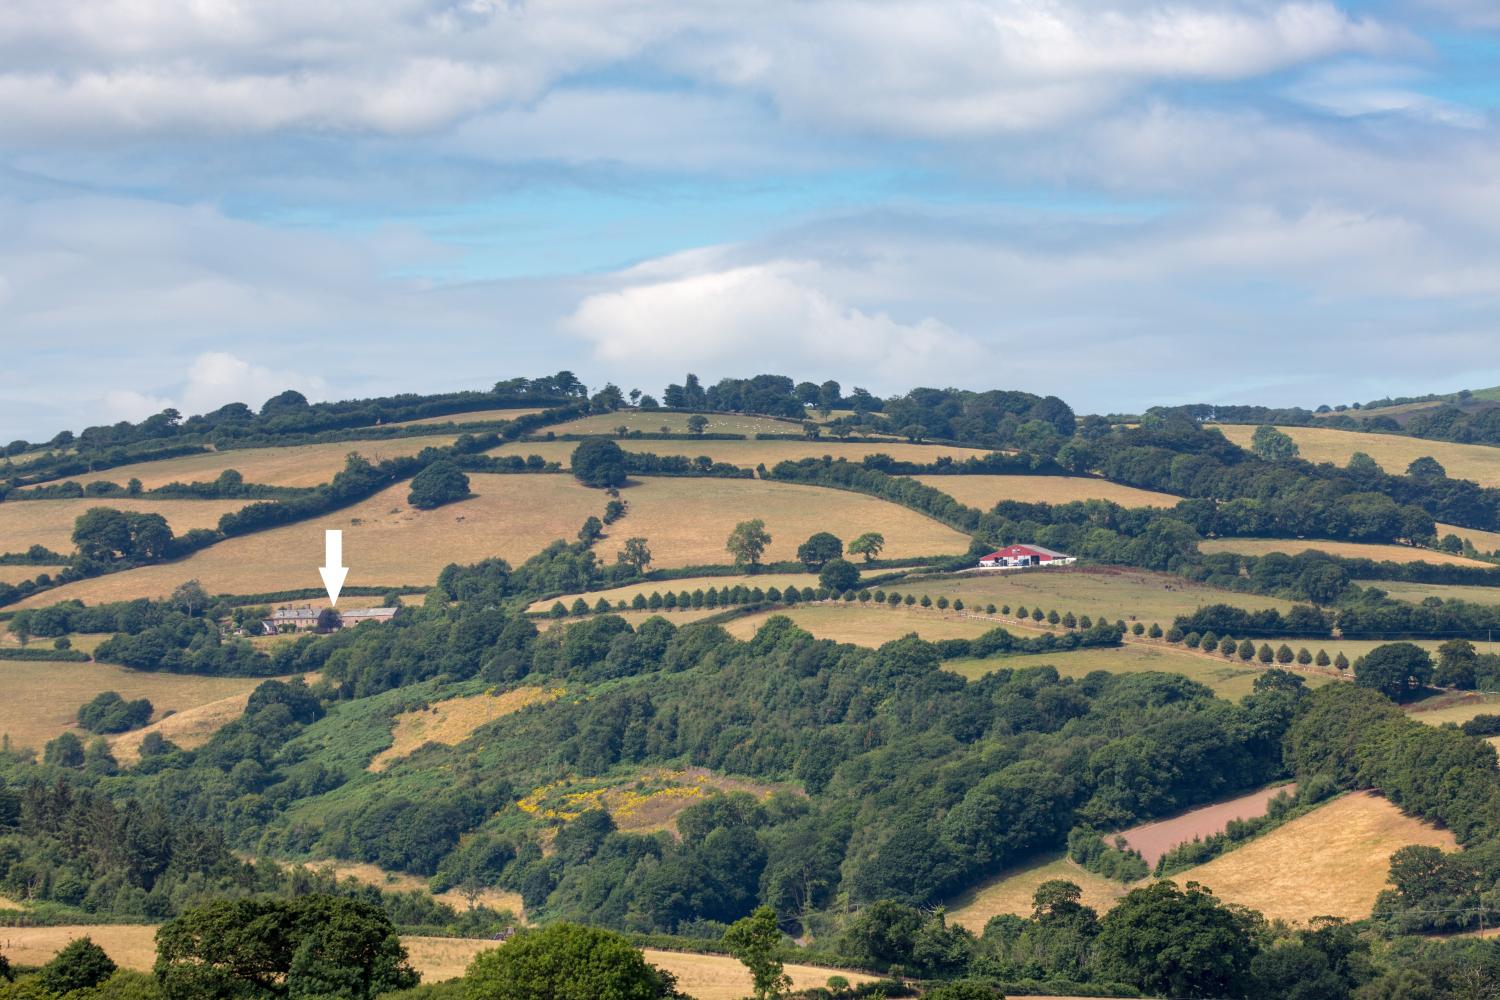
[1173,792,1457,922]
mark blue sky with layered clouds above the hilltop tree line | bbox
[0,0,1500,441]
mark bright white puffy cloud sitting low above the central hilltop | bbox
[564,261,981,382]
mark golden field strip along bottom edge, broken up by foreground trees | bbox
[0,924,873,1000]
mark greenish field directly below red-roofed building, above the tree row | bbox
[887,567,1292,627]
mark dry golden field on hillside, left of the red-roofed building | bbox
[591,477,969,569]
